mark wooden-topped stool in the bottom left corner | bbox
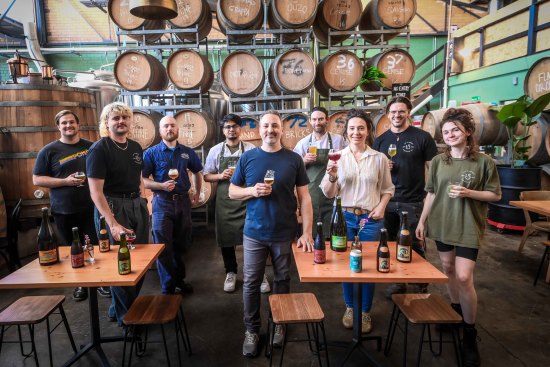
[0,296,77,366]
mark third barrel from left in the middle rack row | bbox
[220,51,265,97]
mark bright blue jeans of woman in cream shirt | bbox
[342,211,384,312]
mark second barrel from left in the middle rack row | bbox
[166,49,214,93]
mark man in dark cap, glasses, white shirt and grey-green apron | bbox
[204,114,255,292]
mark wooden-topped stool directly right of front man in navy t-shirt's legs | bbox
[265,293,329,366]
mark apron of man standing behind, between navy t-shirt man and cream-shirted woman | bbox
[306,133,333,238]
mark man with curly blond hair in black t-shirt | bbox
[86,102,149,326]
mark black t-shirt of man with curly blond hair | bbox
[86,138,143,195]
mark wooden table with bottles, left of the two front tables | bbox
[0,244,164,366]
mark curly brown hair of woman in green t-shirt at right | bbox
[439,108,479,164]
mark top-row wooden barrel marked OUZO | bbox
[267,0,318,42]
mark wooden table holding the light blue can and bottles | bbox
[292,242,448,365]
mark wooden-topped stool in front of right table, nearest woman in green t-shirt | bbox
[384,293,462,366]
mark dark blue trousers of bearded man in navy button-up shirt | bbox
[153,194,191,294]
